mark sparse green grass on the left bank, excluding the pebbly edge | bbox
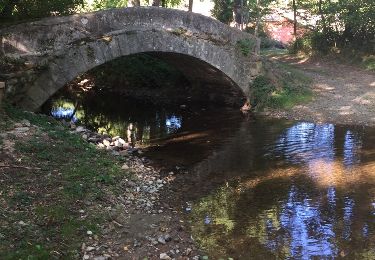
[0,103,128,259]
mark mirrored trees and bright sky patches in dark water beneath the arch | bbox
[44,93,183,145]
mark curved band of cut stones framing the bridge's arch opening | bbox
[21,28,249,110]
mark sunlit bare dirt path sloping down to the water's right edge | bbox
[273,55,375,126]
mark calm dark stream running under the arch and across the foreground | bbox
[48,93,375,259]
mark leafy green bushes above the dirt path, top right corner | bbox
[292,0,375,54]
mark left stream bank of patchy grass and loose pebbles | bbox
[0,104,199,259]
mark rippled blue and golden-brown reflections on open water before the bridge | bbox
[185,121,375,259]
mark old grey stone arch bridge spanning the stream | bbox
[0,7,261,111]
